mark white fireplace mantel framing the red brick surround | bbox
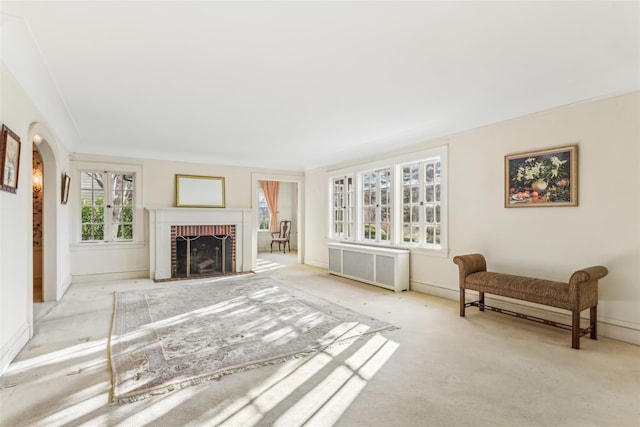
[146,208,252,280]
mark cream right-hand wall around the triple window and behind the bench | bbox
[306,92,640,344]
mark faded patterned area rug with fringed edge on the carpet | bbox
[109,277,393,403]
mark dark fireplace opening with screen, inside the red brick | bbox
[172,234,233,278]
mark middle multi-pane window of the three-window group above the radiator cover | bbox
[362,168,392,241]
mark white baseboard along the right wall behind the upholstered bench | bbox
[411,281,640,345]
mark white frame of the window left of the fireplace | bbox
[69,161,144,247]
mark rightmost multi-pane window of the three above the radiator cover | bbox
[402,158,442,246]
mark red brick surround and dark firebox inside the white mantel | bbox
[171,225,236,278]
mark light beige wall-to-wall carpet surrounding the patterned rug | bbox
[5,252,640,427]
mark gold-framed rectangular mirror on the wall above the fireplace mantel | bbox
[176,175,224,208]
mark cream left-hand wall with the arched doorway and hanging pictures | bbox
[0,65,71,372]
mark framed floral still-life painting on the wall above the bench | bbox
[504,145,578,208]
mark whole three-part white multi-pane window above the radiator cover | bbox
[329,146,448,252]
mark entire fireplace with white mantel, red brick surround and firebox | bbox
[147,207,253,280]
